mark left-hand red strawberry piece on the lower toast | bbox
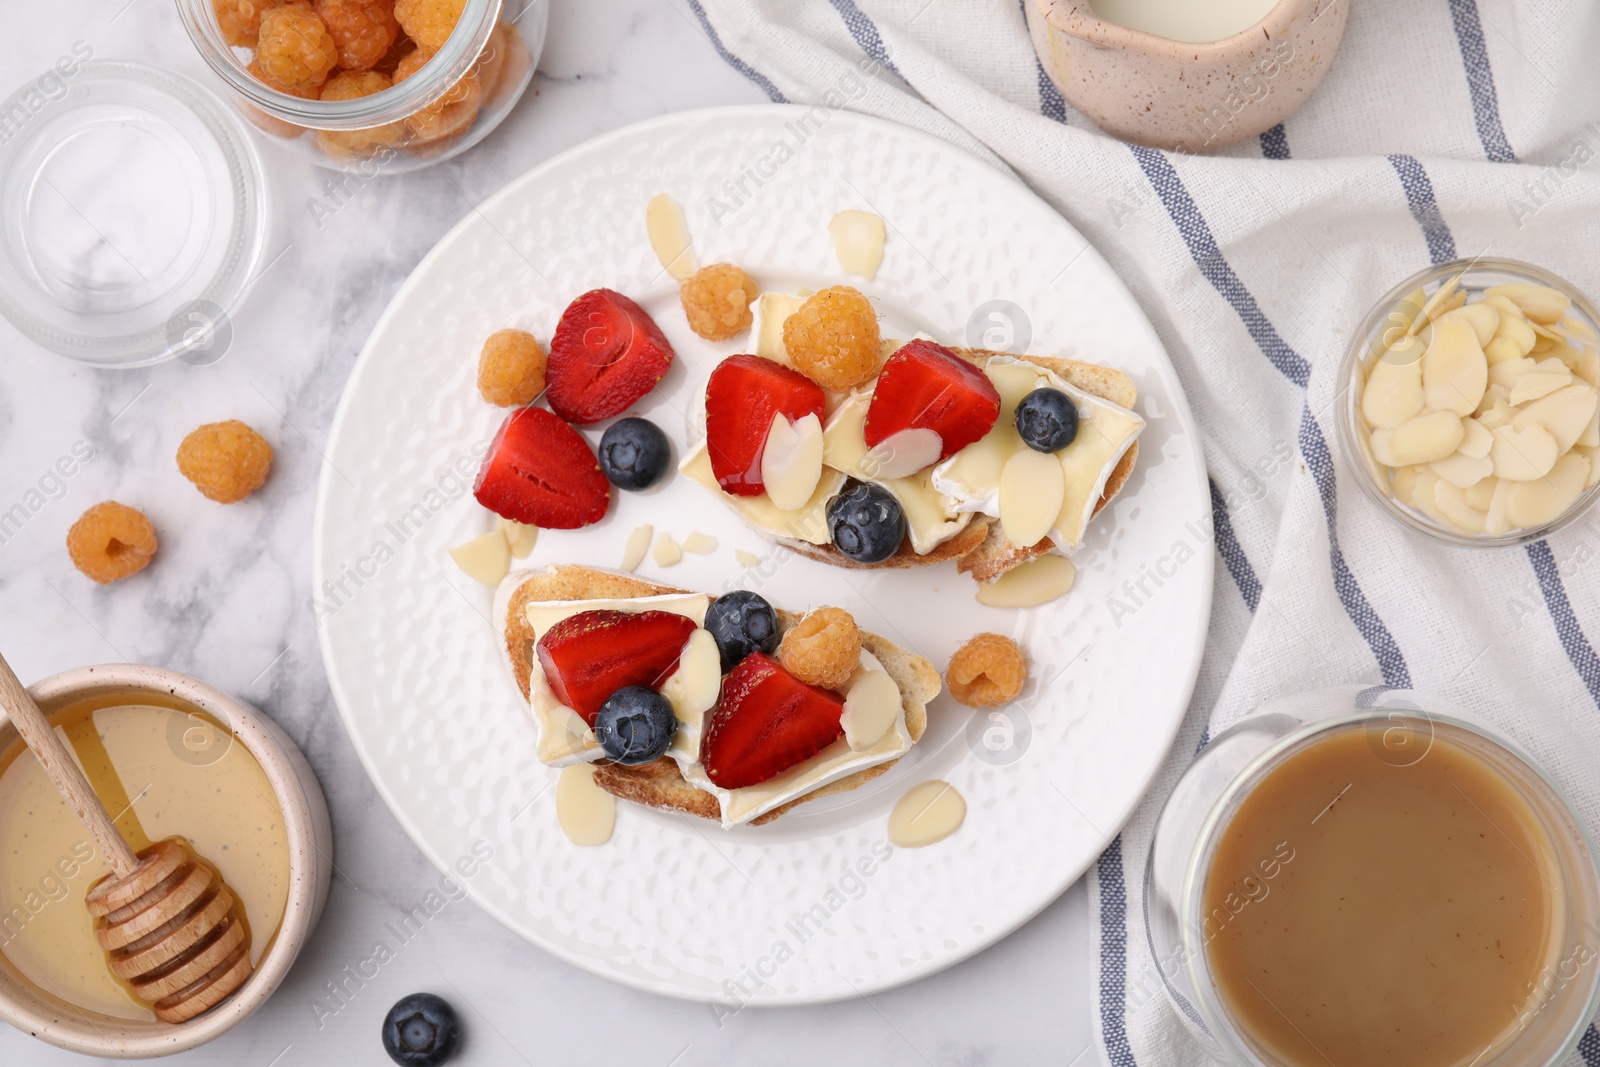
[534,609,694,726]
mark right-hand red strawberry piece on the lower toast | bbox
[701,653,845,789]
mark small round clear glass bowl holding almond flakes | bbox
[1336,259,1600,547]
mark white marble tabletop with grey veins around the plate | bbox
[0,0,1094,1067]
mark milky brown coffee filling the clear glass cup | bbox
[1203,721,1565,1067]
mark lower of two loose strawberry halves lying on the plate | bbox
[472,408,611,530]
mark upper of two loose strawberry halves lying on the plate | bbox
[544,290,672,426]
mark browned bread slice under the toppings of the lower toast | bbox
[494,565,942,825]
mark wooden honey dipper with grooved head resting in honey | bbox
[0,656,251,1022]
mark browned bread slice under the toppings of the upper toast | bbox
[774,349,1139,582]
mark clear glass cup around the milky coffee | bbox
[1144,686,1600,1067]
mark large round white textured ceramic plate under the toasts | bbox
[314,107,1213,1003]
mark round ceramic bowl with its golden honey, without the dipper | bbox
[0,664,333,1059]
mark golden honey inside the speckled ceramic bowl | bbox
[0,693,290,1021]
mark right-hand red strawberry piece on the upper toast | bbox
[864,341,1000,459]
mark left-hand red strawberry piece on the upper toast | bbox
[706,355,824,496]
